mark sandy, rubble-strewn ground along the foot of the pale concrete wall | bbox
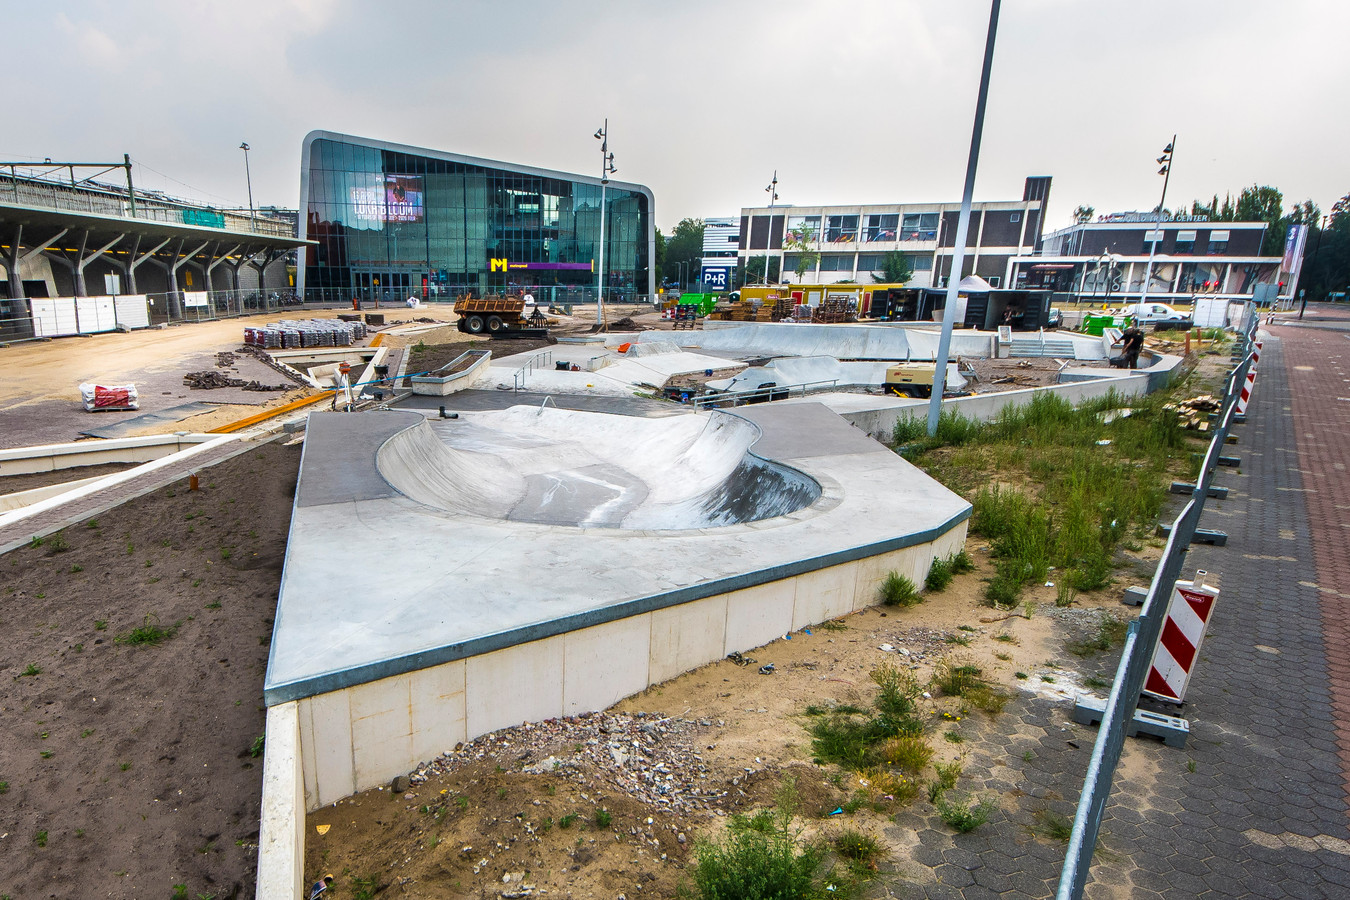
[306,538,1127,899]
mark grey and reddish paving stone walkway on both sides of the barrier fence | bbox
[891,305,1350,900]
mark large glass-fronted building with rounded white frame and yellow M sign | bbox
[300,131,656,304]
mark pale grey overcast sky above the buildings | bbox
[10,0,1350,232]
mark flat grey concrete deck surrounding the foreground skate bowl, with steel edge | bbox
[266,403,969,715]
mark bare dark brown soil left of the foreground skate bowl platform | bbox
[0,443,300,900]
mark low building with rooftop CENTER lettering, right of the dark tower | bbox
[1008,212,1293,304]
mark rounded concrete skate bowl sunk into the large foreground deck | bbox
[375,406,821,529]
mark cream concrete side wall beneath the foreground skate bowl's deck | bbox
[284,531,965,810]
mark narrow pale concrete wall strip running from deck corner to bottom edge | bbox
[254,703,305,900]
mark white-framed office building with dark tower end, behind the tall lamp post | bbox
[738,175,1050,287]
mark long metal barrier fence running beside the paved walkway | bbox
[1056,304,1260,900]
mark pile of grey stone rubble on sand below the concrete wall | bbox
[410,712,726,812]
